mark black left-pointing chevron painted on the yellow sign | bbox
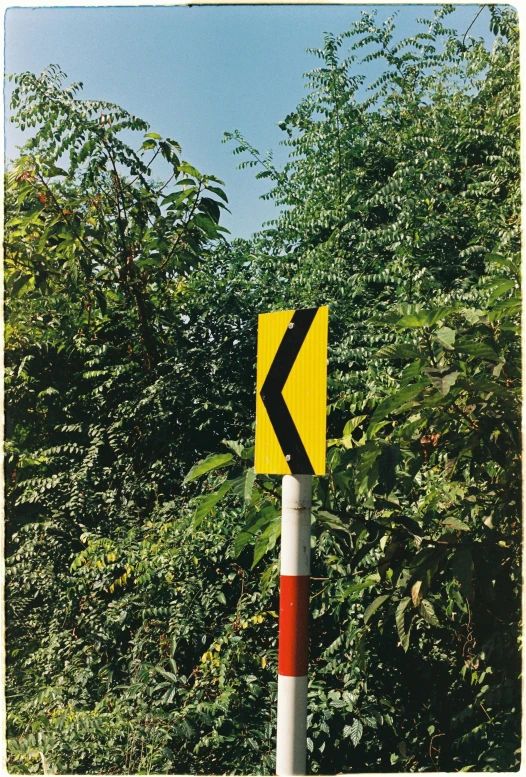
[260,308,318,475]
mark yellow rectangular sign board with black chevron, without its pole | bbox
[255,307,329,475]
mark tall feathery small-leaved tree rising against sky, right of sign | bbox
[227,5,520,416]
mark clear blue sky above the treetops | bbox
[4,4,500,237]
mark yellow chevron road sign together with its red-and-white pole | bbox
[255,307,328,777]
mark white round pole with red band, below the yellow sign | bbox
[276,475,312,777]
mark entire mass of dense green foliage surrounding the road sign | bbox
[4,6,522,774]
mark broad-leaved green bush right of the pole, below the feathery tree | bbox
[192,257,521,773]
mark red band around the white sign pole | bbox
[278,575,310,677]
